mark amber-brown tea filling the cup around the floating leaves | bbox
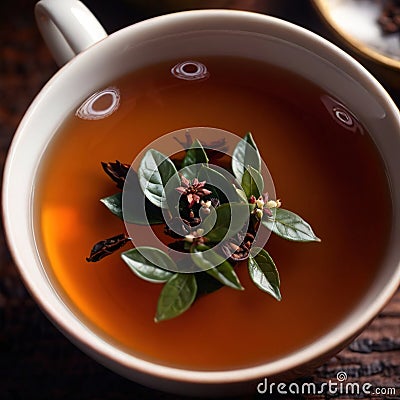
[35,57,392,370]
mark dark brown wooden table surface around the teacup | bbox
[0,0,400,400]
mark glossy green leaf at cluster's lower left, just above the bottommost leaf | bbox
[121,246,177,283]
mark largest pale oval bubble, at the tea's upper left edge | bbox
[75,87,121,120]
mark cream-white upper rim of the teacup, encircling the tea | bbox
[2,10,400,384]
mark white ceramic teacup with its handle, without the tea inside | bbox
[3,0,400,395]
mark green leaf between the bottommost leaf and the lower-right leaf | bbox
[191,246,244,290]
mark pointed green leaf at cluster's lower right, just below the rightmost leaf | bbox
[248,249,282,301]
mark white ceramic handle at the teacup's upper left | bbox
[35,0,107,67]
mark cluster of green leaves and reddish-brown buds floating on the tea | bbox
[87,133,320,322]
